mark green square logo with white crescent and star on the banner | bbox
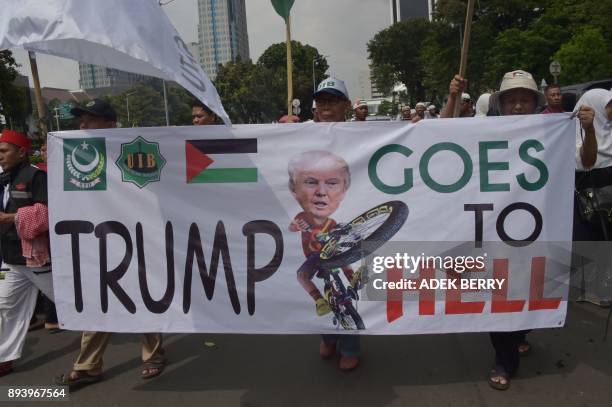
[64,138,106,191]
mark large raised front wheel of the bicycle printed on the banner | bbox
[319,201,408,269]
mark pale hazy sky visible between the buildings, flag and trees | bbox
[13,0,390,99]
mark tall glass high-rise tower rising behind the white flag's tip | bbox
[194,0,249,78]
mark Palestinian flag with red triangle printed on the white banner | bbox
[185,138,257,184]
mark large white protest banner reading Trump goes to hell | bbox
[48,115,575,334]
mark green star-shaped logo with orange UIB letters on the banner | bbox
[115,136,166,188]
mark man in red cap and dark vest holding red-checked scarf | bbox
[0,130,53,376]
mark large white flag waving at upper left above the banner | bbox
[0,0,230,124]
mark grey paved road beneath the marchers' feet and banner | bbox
[0,304,612,407]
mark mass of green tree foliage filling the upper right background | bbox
[368,0,612,101]
